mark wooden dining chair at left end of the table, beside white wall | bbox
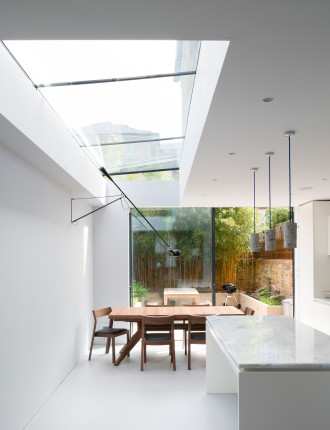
[88,308,129,363]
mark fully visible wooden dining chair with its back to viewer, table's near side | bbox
[141,315,176,371]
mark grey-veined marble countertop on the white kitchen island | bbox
[207,316,330,371]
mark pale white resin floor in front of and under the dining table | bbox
[26,342,237,430]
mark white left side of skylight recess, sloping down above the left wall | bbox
[0,44,105,196]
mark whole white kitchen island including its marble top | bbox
[206,316,330,430]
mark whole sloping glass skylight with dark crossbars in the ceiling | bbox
[4,41,200,175]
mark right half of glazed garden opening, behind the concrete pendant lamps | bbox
[215,207,293,306]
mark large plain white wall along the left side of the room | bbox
[0,144,92,430]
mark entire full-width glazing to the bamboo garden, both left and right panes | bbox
[131,207,293,306]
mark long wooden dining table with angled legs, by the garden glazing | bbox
[109,306,244,366]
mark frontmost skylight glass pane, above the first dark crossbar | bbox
[4,40,200,84]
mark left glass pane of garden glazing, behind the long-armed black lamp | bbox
[131,208,212,306]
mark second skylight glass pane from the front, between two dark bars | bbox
[40,75,194,145]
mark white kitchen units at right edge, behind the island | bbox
[295,201,330,335]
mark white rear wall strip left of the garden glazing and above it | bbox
[93,181,179,330]
